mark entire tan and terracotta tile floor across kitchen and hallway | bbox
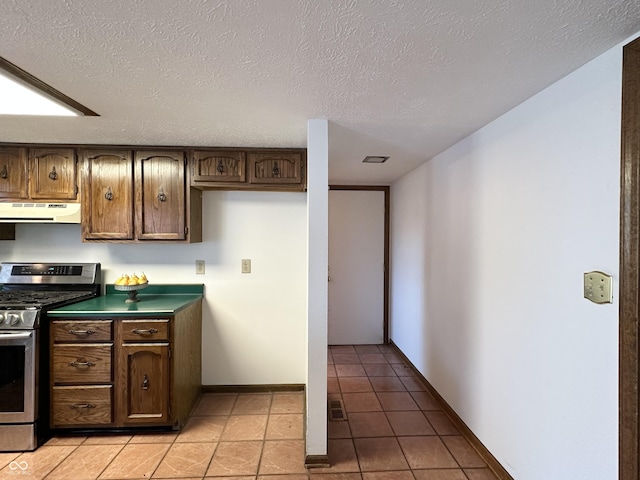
[0,345,495,480]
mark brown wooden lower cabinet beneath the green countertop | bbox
[50,302,202,429]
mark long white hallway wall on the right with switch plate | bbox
[390,35,622,480]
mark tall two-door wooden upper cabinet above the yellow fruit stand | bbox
[82,150,195,242]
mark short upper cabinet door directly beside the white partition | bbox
[249,152,303,185]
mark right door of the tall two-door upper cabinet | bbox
[135,151,186,240]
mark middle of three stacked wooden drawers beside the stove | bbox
[53,343,113,384]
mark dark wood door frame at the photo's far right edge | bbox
[618,38,640,480]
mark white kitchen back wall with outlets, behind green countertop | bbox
[0,191,307,385]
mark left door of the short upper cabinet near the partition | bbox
[191,150,246,184]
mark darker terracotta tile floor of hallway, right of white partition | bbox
[324,345,496,480]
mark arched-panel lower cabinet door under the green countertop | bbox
[117,343,170,425]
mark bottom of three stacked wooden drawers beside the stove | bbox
[51,385,113,427]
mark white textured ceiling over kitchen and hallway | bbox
[0,0,640,184]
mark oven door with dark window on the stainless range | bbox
[0,330,38,424]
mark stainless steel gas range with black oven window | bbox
[0,262,102,452]
